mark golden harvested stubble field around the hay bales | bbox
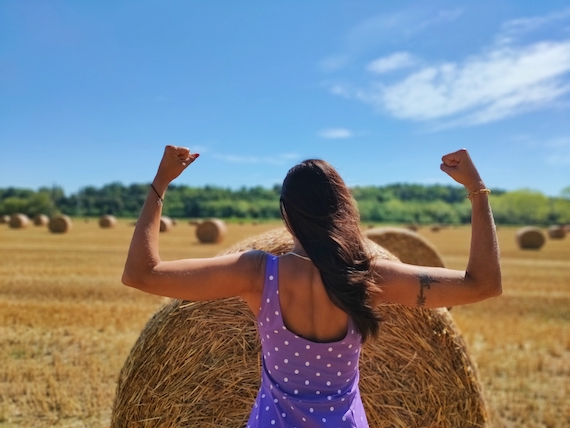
[0,220,570,428]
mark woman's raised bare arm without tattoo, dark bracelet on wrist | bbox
[122,146,264,307]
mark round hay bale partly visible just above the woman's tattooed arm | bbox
[364,227,444,267]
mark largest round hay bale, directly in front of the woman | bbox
[111,229,488,428]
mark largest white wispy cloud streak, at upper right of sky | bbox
[331,12,570,127]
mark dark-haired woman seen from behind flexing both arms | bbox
[123,146,501,428]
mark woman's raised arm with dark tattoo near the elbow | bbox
[373,149,502,308]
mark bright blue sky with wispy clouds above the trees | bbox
[0,0,570,196]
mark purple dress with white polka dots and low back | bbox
[246,255,368,428]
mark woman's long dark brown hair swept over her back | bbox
[280,159,380,341]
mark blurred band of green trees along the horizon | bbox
[0,183,570,225]
